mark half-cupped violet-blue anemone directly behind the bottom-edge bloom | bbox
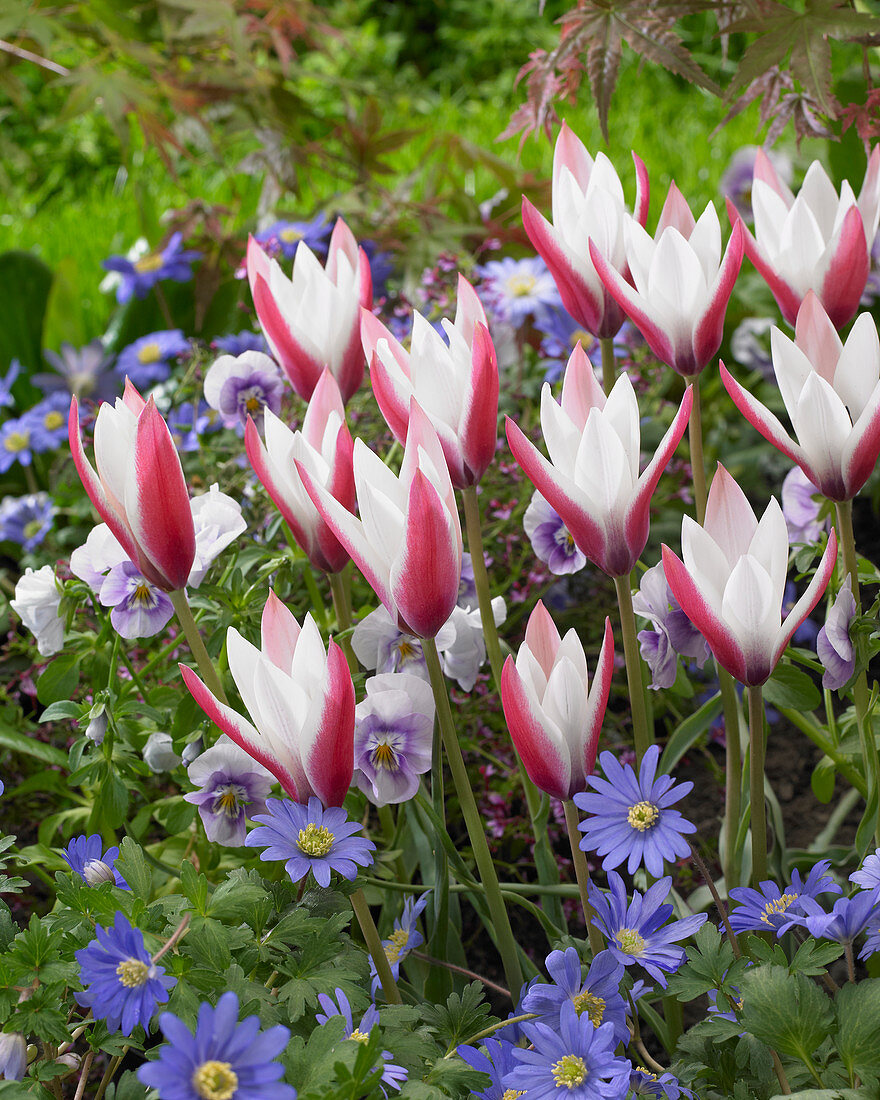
[520,947,629,1043]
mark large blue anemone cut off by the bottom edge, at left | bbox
[138,992,296,1100]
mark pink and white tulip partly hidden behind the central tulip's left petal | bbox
[244,370,355,573]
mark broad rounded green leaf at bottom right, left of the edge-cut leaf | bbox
[739,966,834,1065]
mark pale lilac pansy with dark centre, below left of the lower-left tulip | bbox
[184,734,275,848]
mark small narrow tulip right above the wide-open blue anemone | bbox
[502,600,614,800]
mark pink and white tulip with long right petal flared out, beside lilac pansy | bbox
[663,463,837,686]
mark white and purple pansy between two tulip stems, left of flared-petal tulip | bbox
[633,562,710,690]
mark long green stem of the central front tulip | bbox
[421,638,523,1001]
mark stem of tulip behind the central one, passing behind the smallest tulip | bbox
[462,485,565,927]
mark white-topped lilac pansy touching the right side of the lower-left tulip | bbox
[354,672,435,806]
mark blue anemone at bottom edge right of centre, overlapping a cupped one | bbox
[504,1002,633,1100]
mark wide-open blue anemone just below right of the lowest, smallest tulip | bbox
[574,745,696,877]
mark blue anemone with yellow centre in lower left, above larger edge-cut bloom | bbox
[74,913,177,1035]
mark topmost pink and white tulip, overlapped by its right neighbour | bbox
[523,122,649,338]
